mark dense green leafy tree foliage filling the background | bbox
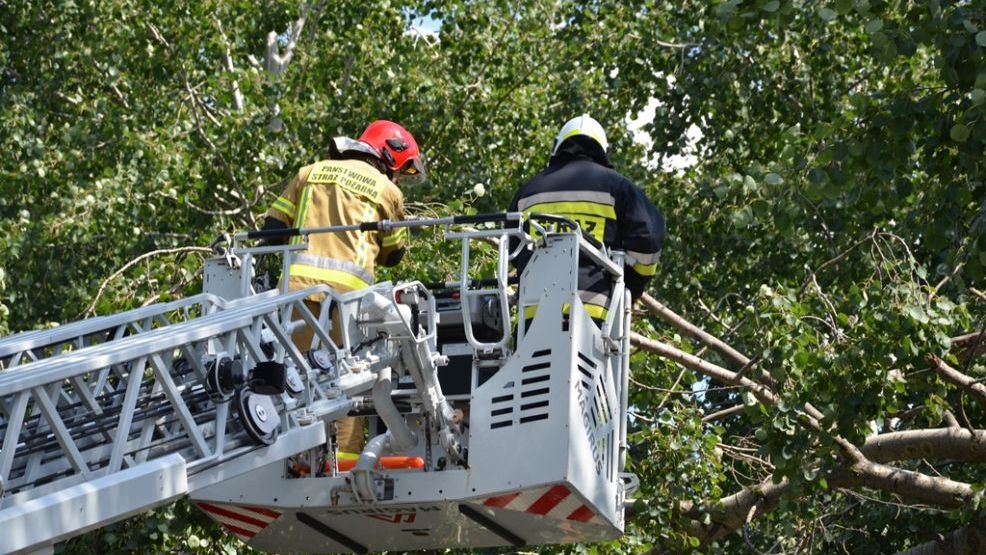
[0,0,986,553]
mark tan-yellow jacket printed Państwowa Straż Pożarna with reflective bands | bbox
[267,159,407,301]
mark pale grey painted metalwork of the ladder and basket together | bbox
[0,214,630,552]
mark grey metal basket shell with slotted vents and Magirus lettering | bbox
[192,226,630,552]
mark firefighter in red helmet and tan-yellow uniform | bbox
[264,120,425,458]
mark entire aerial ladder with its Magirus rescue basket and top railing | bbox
[0,213,636,553]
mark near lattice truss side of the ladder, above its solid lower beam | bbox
[0,288,332,507]
